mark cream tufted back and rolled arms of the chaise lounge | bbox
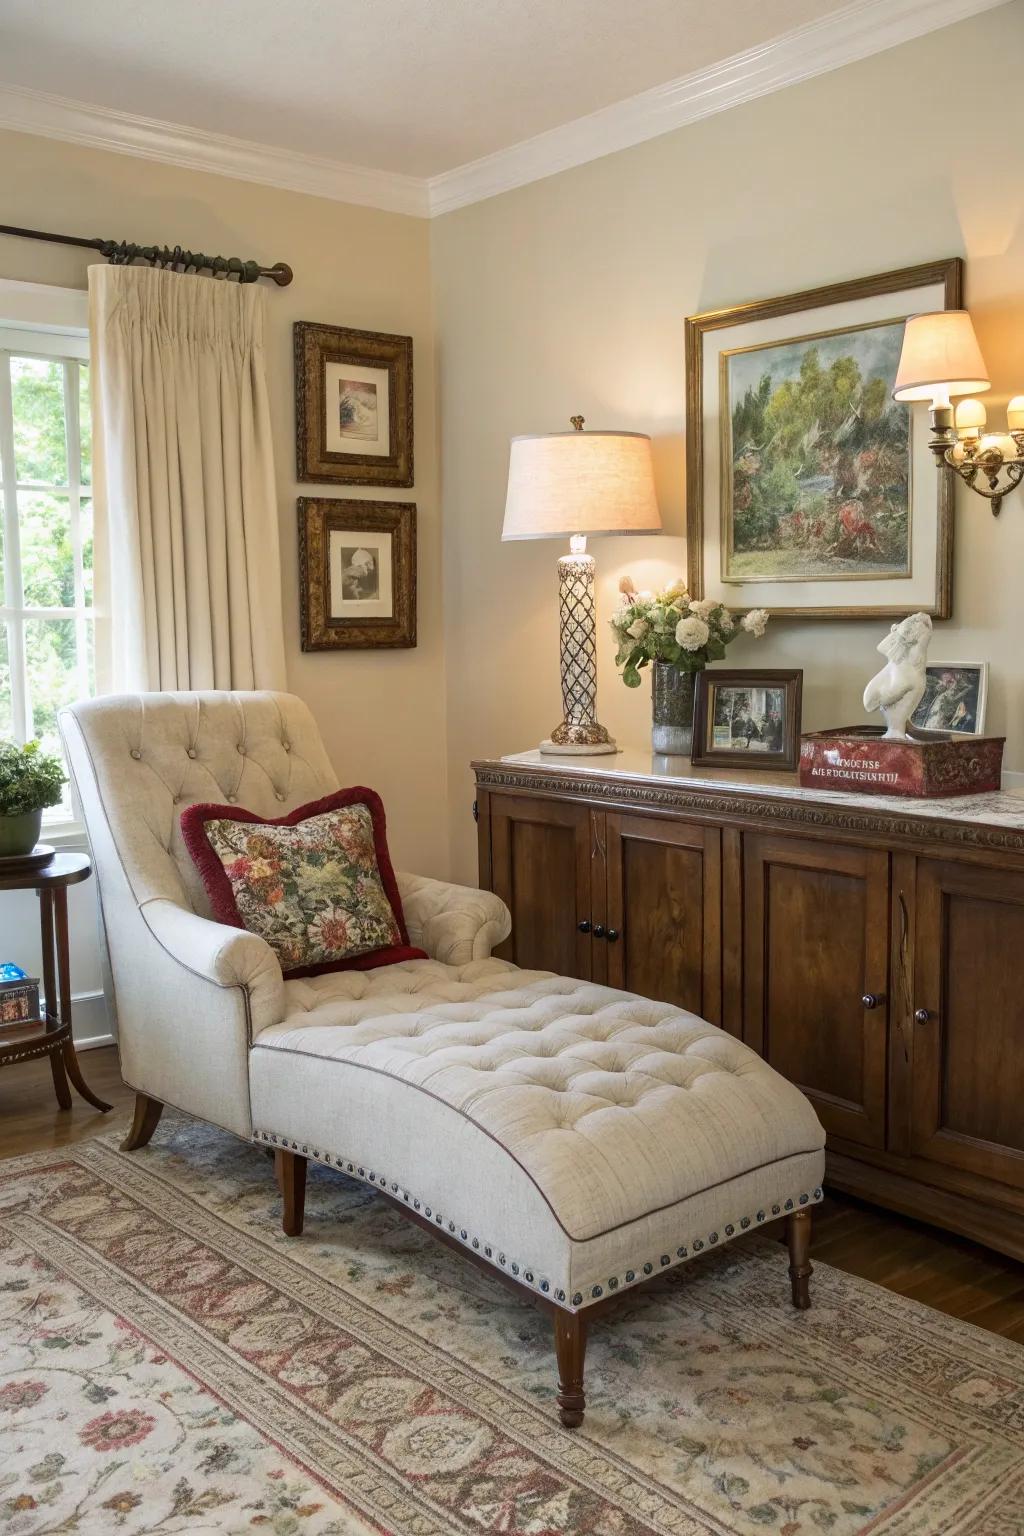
[61,693,508,1135]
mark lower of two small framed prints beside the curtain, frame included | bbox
[299,496,416,651]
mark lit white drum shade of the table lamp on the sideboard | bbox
[502,432,662,539]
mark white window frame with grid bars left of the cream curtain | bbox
[0,278,94,843]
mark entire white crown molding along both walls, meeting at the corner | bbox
[0,0,1009,218]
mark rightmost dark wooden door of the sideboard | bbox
[910,859,1024,1189]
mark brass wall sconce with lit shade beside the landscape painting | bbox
[892,309,1024,518]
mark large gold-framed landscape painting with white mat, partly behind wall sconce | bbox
[686,258,963,617]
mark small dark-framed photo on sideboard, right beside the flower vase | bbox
[691,667,803,770]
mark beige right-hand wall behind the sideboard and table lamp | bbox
[431,0,1024,877]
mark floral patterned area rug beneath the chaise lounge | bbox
[0,1118,1024,1536]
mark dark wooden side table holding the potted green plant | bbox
[0,852,112,1112]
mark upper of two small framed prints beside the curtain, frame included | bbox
[295,319,413,485]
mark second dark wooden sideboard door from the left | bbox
[606,814,722,1025]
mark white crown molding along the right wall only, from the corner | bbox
[428,0,1007,218]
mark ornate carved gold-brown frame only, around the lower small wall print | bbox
[298,496,416,651]
